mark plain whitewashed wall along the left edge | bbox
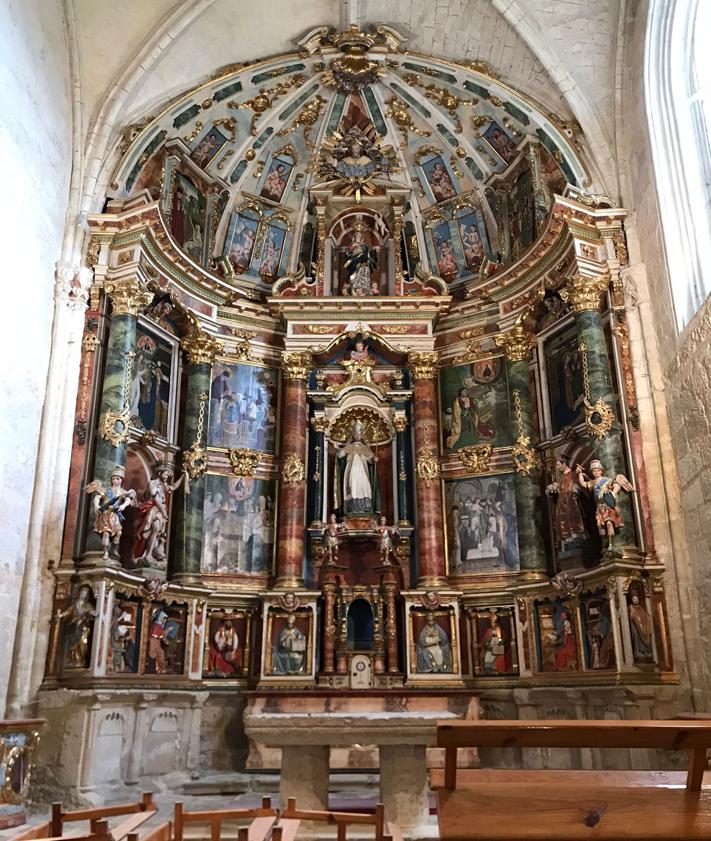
[0,0,71,715]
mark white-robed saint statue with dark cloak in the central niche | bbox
[333,420,380,516]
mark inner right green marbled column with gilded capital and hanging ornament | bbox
[496,323,547,577]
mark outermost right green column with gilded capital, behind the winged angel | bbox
[561,275,635,544]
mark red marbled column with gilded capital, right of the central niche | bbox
[409,351,446,587]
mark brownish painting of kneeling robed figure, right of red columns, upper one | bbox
[440,356,512,453]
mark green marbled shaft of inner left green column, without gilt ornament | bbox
[169,364,210,577]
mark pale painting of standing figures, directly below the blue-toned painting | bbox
[200,473,276,576]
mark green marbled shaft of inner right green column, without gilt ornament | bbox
[507,360,547,572]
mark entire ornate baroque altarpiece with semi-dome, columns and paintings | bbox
[42,26,675,786]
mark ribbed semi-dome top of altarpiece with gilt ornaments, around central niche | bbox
[112,26,588,293]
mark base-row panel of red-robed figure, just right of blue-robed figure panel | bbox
[469,607,518,677]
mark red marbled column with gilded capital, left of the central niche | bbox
[276,351,312,587]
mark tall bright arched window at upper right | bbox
[645,0,711,329]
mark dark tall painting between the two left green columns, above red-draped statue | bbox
[129,320,177,440]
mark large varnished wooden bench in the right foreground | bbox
[433,721,711,841]
